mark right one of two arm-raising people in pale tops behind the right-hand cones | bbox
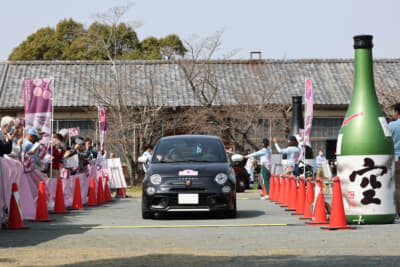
[272,136,301,176]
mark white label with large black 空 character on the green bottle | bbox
[337,155,396,215]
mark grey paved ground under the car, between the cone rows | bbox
[0,193,400,266]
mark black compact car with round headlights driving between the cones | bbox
[139,135,236,219]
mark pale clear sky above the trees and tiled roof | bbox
[0,0,400,60]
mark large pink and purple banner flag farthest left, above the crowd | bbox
[23,78,52,141]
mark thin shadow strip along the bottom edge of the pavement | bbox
[50,254,400,267]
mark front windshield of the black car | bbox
[152,138,227,163]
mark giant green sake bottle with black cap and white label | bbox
[336,35,395,224]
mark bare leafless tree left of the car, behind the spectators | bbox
[67,3,170,185]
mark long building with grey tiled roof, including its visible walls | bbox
[0,59,400,155]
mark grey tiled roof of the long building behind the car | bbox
[0,59,400,109]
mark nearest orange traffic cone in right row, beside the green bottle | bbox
[321,176,356,230]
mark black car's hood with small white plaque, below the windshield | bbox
[150,163,230,177]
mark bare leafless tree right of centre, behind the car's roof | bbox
[178,31,288,150]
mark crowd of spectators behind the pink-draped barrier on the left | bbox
[0,116,107,178]
